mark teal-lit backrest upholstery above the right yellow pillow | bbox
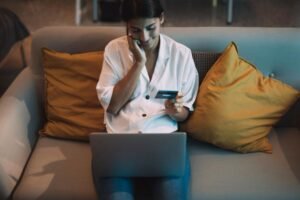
[162,27,300,89]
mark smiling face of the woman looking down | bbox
[127,17,163,50]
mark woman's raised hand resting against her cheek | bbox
[127,35,147,65]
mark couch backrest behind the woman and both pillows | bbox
[32,27,300,89]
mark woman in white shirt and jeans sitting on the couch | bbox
[96,0,198,200]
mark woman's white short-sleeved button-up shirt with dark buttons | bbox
[96,34,199,133]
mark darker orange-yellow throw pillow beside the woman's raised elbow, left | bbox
[40,49,105,140]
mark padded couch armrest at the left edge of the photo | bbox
[0,67,43,199]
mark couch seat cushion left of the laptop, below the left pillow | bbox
[13,137,97,200]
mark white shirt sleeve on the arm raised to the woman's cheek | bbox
[96,45,120,110]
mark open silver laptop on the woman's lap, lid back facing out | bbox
[90,132,186,177]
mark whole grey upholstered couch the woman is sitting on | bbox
[0,27,300,200]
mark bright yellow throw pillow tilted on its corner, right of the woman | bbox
[182,43,300,153]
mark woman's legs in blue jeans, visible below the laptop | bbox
[94,158,190,200]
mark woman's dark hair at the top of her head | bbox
[121,0,164,22]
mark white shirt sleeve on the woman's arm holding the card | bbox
[181,49,199,111]
